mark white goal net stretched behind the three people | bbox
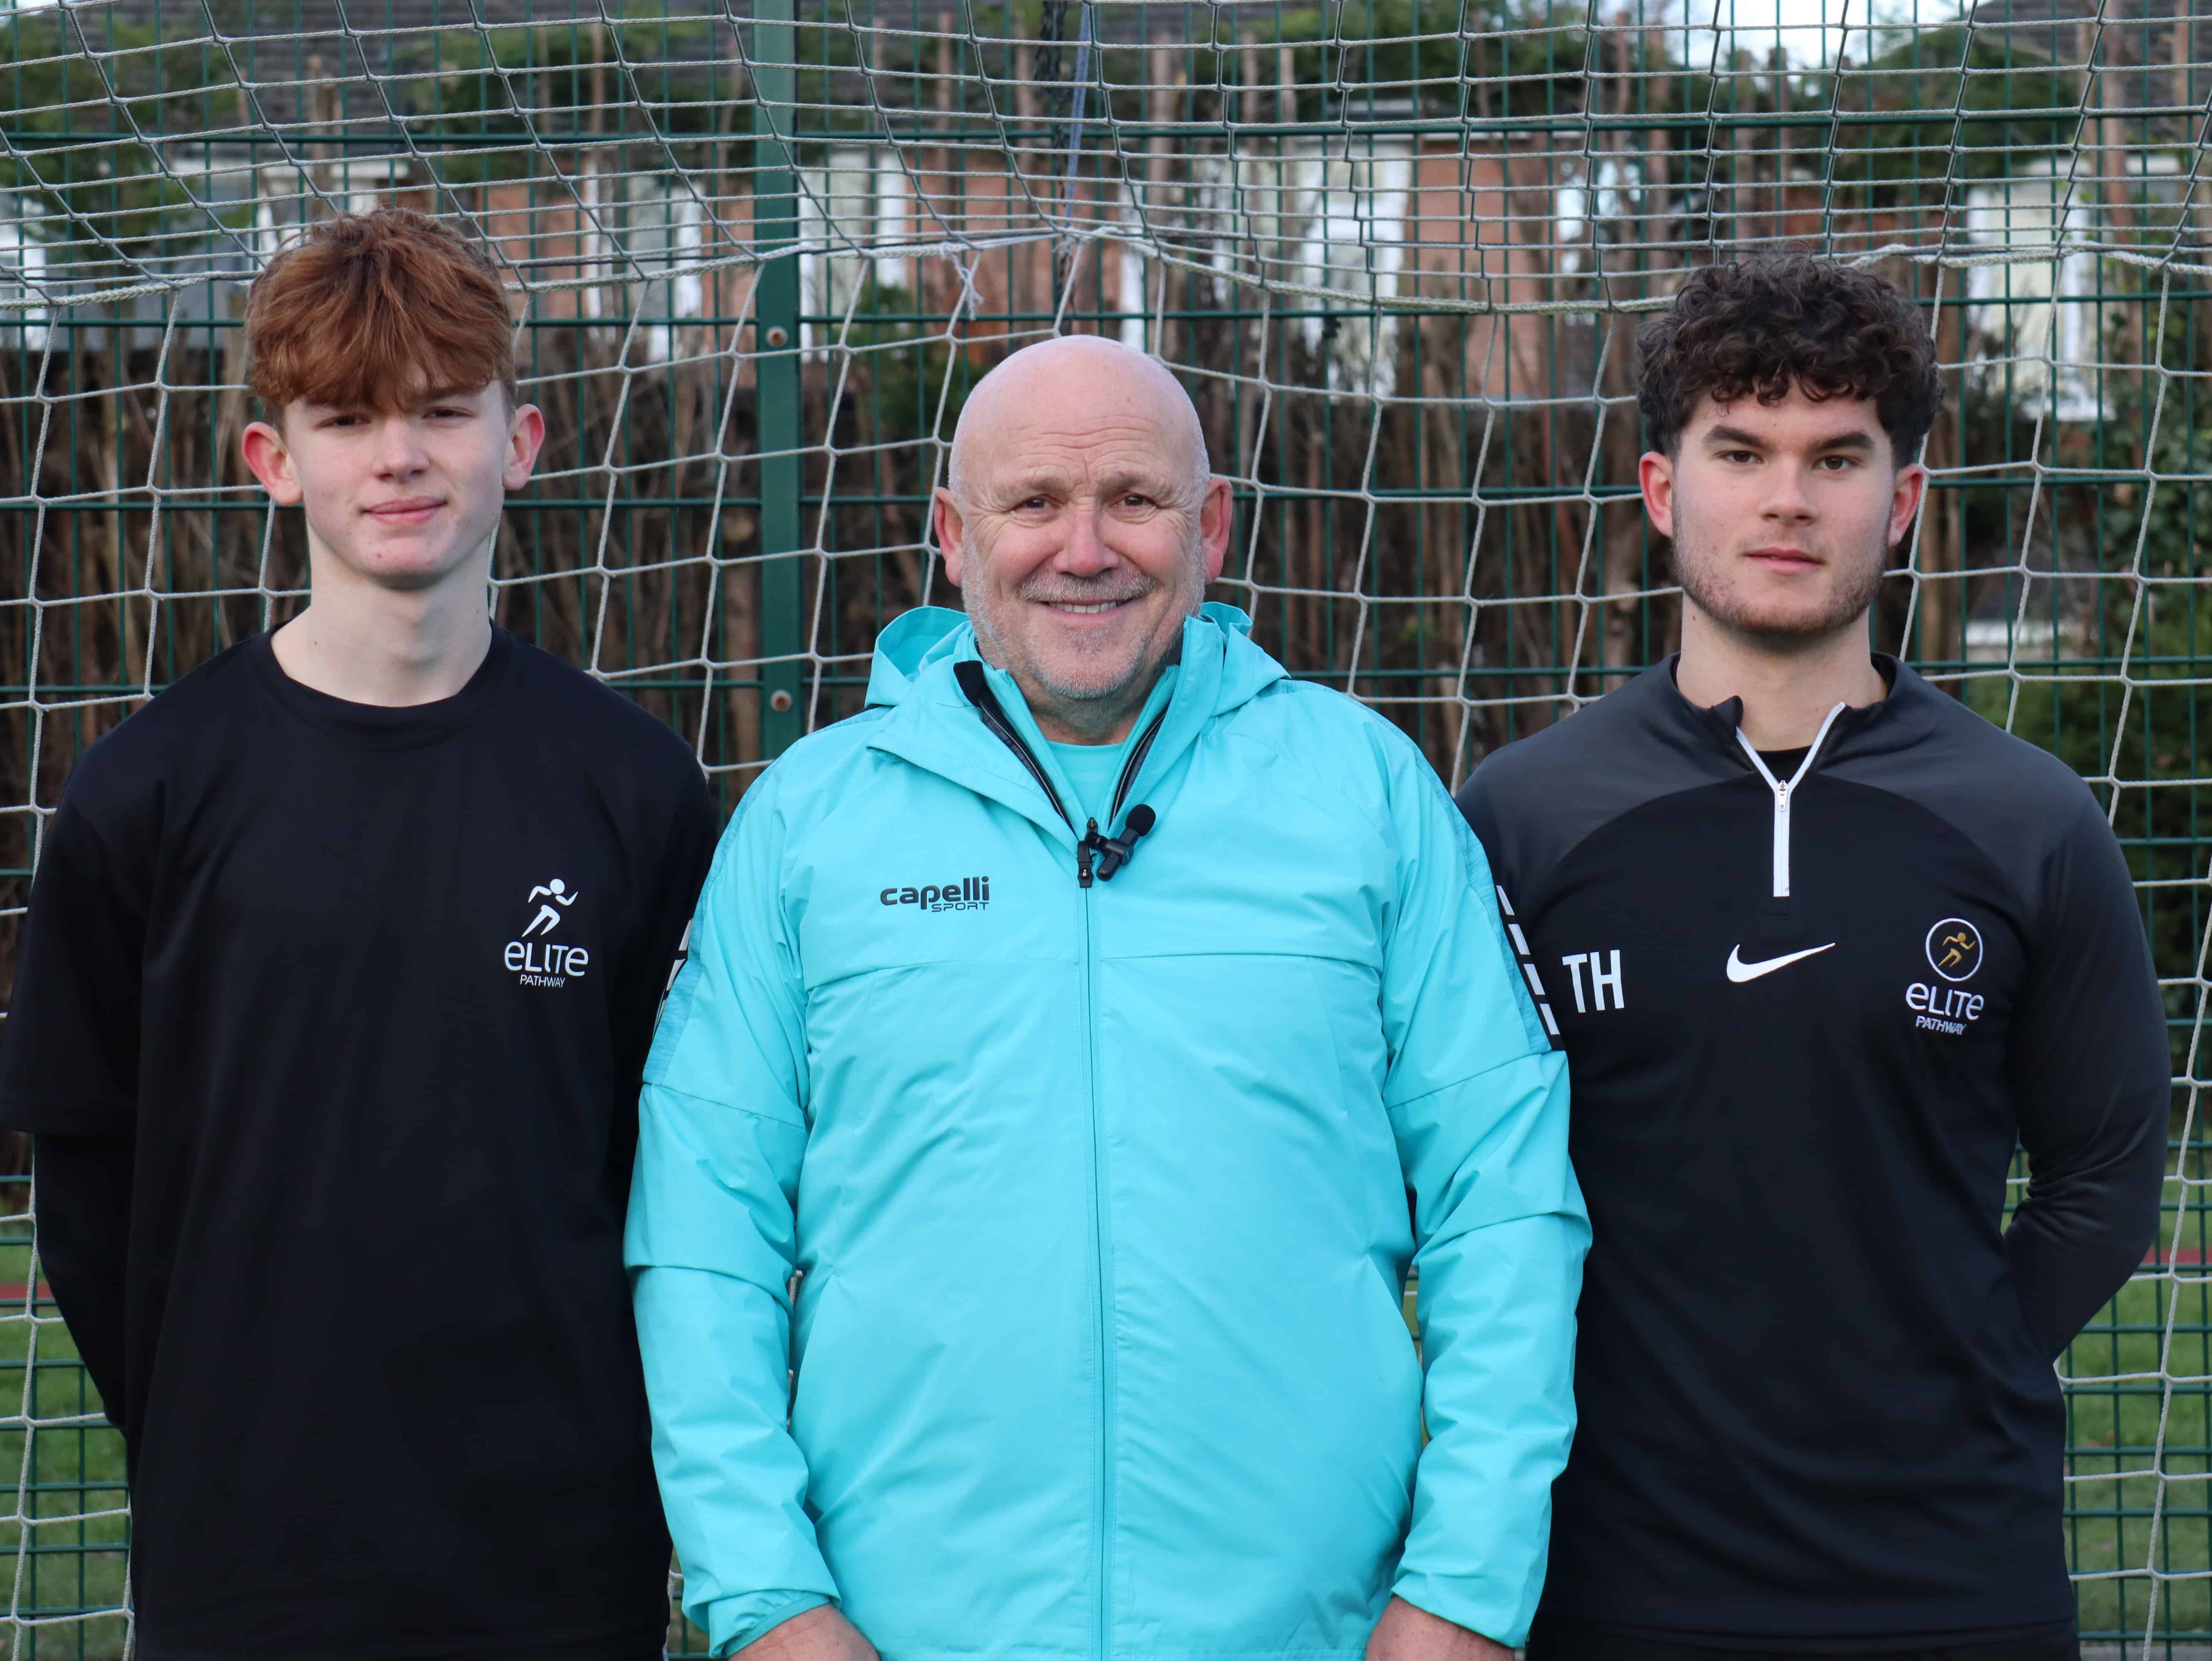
[0,0,2212,1656]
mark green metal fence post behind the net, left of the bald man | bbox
[752,0,805,761]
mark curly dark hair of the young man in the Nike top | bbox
[1637,255,1942,467]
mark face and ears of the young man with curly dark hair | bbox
[1641,387,1927,648]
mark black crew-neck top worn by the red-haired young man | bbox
[0,630,714,1661]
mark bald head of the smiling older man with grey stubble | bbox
[938,338,1230,743]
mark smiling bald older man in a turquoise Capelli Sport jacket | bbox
[628,338,1588,1661]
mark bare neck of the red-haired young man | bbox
[270,549,491,710]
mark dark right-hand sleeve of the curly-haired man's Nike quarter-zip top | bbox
[2004,803,2172,1358]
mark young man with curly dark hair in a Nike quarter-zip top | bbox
[1460,255,2170,1661]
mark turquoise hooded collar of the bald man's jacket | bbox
[867,602,1285,849]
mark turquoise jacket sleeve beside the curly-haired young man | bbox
[1382,763,1590,1646]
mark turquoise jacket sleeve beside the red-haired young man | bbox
[626,777,836,1654]
